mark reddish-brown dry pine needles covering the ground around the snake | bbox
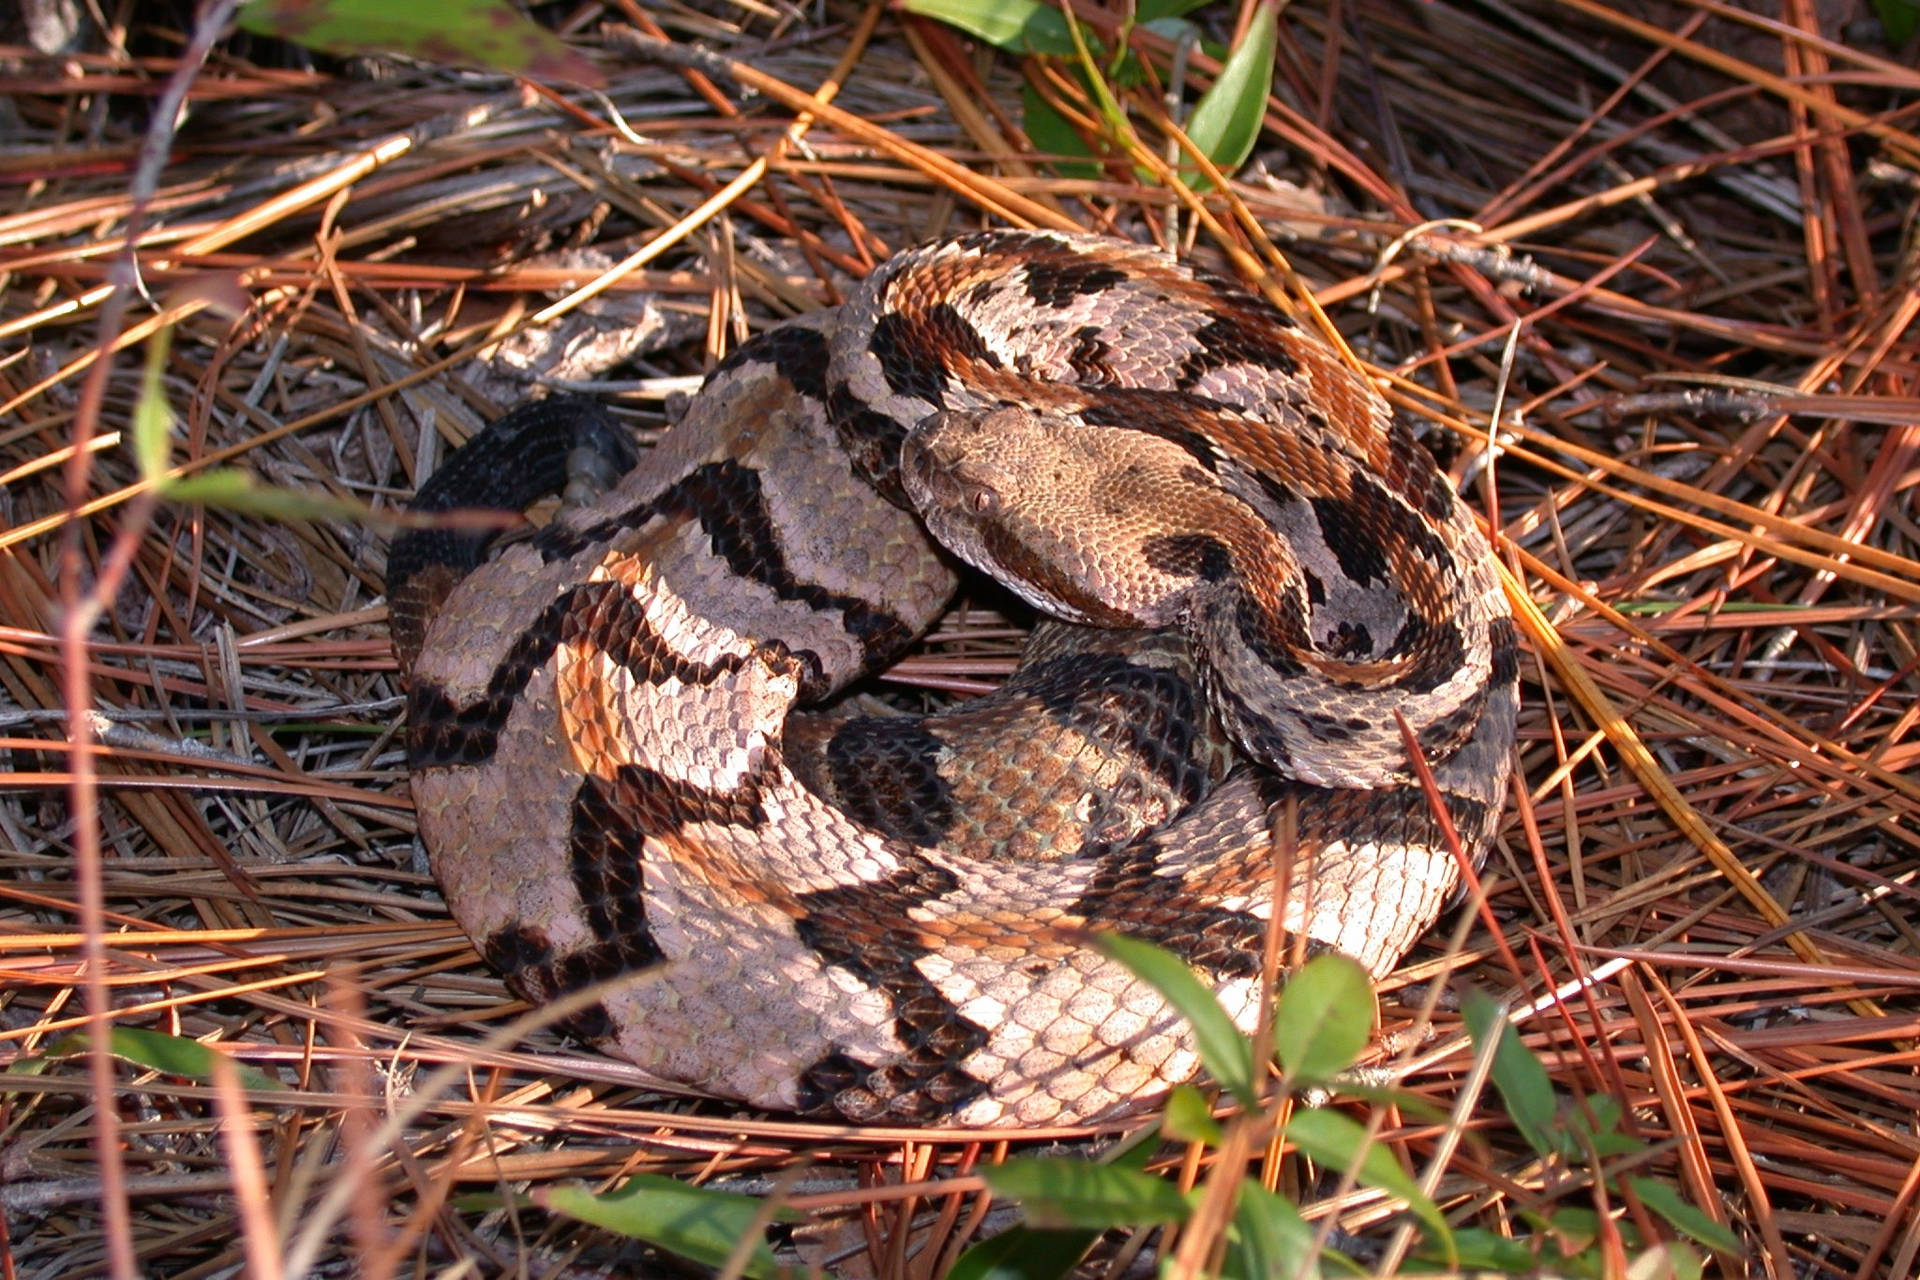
[0,0,1920,1278]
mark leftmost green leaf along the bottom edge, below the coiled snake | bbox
[534,1173,801,1280]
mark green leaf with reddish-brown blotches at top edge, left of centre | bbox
[238,0,607,88]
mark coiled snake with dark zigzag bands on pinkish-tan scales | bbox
[388,232,1519,1125]
